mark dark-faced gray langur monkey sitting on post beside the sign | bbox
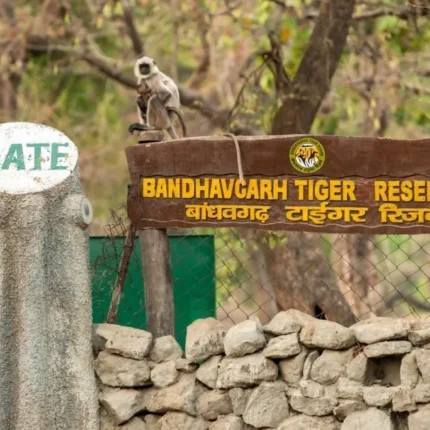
[129,57,186,139]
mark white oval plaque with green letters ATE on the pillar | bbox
[0,122,78,194]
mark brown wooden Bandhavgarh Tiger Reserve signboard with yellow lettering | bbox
[126,136,430,234]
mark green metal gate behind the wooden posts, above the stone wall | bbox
[89,235,215,347]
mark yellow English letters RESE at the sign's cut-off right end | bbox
[374,180,430,202]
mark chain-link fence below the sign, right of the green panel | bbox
[215,229,430,324]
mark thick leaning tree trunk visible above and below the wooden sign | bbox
[265,0,356,325]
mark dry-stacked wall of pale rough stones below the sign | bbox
[94,310,430,430]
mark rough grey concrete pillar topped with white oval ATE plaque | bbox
[0,123,99,430]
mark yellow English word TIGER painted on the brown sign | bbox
[294,179,357,202]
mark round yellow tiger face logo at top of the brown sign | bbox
[290,137,325,173]
